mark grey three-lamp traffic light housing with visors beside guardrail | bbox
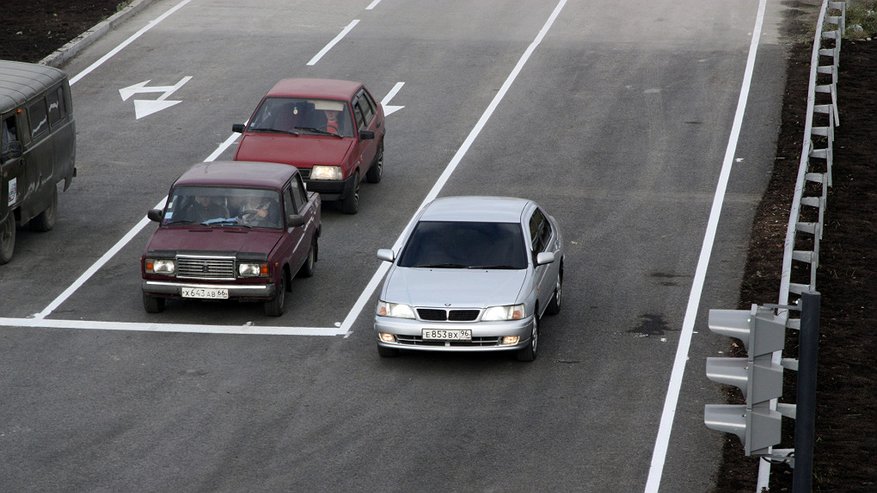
[703,305,787,456]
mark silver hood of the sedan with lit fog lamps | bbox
[383,267,528,308]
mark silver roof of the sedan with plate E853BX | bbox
[420,196,536,223]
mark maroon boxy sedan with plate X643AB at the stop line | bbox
[140,161,321,316]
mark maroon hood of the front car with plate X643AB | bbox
[146,226,282,256]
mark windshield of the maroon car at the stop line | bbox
[162,187,283,228]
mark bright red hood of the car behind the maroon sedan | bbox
[234,133,354,168]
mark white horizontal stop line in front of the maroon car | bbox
[0,318,344,336]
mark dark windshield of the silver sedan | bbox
[399,221,527,269]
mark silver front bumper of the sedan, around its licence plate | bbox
[374,316,533,352]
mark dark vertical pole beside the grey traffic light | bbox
[792,292,821,493]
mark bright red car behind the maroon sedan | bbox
[232,79,385,214]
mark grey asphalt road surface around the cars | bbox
[0,0,784,492]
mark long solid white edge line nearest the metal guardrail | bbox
[645,0,766,493]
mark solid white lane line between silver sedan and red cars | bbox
[341,0,566,330]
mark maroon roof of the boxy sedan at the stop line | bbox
[174,161,298,188]
